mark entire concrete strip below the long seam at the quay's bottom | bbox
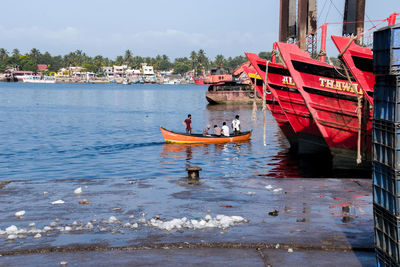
[0,246,375,267]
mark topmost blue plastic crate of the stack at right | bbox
[373,24,400,75]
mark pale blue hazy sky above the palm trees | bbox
[0,0,400,59]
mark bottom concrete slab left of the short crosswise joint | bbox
[0,247,264,267]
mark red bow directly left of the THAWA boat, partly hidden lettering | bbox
[246,53,329,154]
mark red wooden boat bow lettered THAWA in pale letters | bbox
[278,43,372,169]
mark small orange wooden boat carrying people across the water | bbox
[160,127,251,144]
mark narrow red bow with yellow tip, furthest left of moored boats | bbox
[243,67,298,151]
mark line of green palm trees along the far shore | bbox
[0,48,271,75]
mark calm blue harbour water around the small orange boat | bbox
[0,83,344,180]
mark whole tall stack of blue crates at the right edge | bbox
[372,24,400,266]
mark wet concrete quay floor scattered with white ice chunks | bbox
[0,176,374,265]
